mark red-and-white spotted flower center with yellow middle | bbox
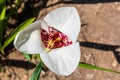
[41,27,72,52]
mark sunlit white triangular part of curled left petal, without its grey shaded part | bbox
[19,30,44,54]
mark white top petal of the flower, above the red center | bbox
[44,7,81,42]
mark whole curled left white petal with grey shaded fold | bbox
[14,20,44,54]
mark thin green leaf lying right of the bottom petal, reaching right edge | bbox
[78,62,120,74]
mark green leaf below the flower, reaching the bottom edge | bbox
[30,61,44,80]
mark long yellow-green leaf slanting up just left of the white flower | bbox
[2,18,35,49]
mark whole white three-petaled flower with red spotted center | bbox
[14,7,81,75]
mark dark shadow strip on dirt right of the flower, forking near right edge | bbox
[80,41,120,63]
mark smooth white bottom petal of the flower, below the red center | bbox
[40,43,80,75]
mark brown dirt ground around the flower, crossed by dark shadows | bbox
[0,0,120,80]
